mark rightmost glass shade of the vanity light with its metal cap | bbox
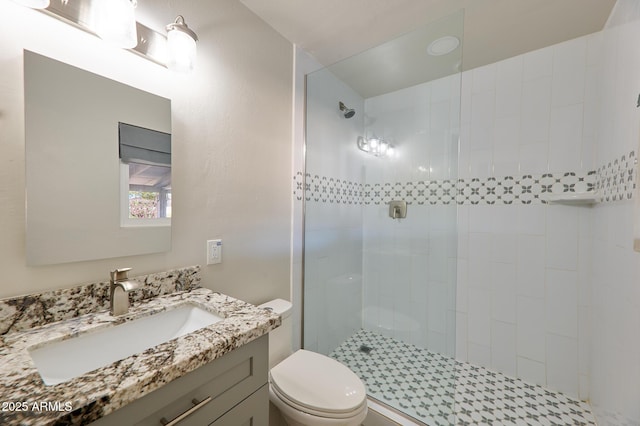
[166,15,198,72]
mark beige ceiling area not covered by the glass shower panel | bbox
[241,0,615,70]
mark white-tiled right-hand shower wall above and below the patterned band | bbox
[589,0,640,426]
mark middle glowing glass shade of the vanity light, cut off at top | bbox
[94,0,138,49]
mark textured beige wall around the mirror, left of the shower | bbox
[0,0,293,302]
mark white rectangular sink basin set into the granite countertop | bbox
[29,304,223,385]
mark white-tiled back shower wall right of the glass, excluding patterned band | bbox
[456,34,602,398]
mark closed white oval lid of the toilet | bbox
[270,349,367,413]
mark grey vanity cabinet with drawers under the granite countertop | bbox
[91,334,269,426]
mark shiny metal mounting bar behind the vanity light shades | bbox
[38,0,167,66]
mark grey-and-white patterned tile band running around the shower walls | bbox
[293,151,637,205]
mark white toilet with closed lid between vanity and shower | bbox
[259,299,367,426]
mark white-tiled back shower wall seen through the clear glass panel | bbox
[361,74,460,356]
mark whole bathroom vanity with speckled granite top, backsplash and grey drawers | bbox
[0,267,281,426]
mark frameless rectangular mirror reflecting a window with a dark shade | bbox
[24,51,171,265]
